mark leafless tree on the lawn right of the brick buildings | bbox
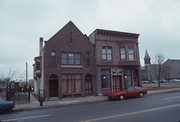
[153,53,168,87]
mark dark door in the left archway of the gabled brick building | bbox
[49,79,58,97]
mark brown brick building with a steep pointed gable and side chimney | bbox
[34,21,96,98]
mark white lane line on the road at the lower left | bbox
[1,114,51,122]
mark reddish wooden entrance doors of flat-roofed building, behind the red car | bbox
[112,76,122,92]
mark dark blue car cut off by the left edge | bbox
[0,99,15,113]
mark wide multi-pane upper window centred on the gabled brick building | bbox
[61,53,81,64]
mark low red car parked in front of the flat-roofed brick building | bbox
[108,87,147,100]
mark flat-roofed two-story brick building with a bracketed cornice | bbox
[89,29,140,95]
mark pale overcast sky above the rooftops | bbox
[0,0,180,78]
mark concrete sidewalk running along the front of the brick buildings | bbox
[14,88,180,111]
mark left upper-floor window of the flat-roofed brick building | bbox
[102,47,112,61]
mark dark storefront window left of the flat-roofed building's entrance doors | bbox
[101,70,110,88]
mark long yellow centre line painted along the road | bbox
[80,104,180,122]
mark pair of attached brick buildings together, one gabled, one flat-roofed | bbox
[34,21,140,98]
